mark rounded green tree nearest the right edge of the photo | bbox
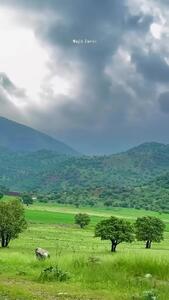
[135,216,165,249]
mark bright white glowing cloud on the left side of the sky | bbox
[0,7,81,109]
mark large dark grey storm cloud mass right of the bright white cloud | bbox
[0,0,169,153]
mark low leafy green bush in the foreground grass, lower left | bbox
[39,266,70,282]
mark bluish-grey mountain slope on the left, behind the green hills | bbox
[0,116,77,155]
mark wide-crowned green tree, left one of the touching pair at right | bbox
[95,217,134,252]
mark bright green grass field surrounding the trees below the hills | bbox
[0,196,169,300]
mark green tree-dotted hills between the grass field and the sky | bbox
[0,143,169,212]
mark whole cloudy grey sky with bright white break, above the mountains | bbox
[0,0,169,154]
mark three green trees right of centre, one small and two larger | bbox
[75,214,165,252]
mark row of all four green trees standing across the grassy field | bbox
[0,200,165,252]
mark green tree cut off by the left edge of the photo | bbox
[0,200,27,247]
